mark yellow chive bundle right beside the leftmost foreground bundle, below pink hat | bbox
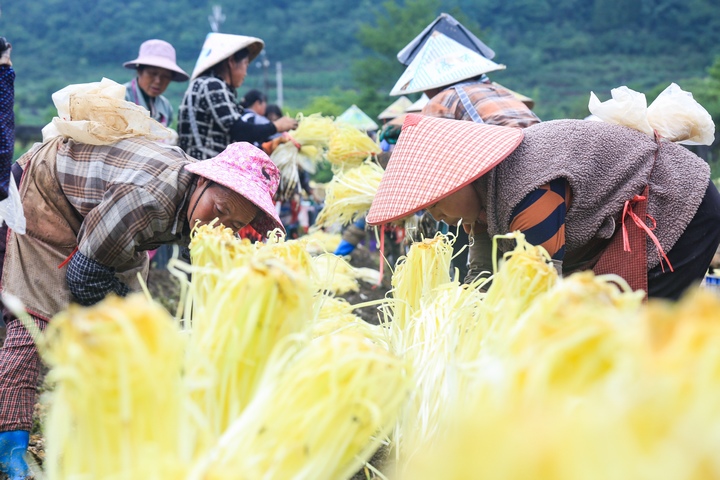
[186,257,313,448]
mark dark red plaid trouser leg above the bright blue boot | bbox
[0,316,47,432]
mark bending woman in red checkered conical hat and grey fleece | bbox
[367,115,720,298]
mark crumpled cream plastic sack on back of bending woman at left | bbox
[43,78,173,145]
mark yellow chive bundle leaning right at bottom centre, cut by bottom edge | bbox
[187,333,407,480]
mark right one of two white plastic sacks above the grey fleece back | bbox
[647,83,715,145]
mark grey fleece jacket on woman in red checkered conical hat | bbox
[476,120,710,269]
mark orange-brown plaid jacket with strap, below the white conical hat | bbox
[422,82,540,128]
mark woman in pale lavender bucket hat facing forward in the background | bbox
[123,39,190,127]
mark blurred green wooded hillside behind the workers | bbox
[0,0,720,158]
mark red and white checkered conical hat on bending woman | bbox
[367,114,523,225]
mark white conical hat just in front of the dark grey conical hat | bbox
[390,32,505,95]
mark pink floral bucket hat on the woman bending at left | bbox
[185,142,285,236]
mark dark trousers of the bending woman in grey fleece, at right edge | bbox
[648,182,720,300]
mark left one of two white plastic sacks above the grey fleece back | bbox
[588,86,653,135]
